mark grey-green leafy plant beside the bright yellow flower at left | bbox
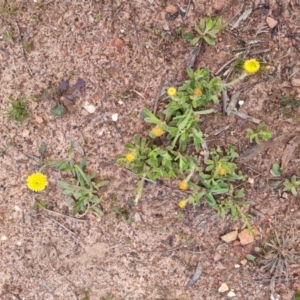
[47,144,109,218]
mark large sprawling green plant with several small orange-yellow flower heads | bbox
[118,57,261,230]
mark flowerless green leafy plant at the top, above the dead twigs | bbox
[190,17,226,45]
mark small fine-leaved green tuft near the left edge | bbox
[6,96,31,125]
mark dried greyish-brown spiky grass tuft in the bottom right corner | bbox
[260,231,300,292]
